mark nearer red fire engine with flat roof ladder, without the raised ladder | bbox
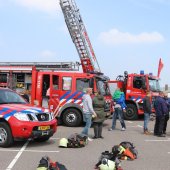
[0,63,111,126]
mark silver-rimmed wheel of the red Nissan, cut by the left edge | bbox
[0,122,14,148]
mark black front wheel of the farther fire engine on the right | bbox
[124,104,138,120]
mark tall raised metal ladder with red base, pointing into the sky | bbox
[60,0,100,73]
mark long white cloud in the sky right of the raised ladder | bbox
[99,29,164,45]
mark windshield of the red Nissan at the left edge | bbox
[0,90,27,104]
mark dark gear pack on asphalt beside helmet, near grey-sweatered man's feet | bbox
[68,133,88,148]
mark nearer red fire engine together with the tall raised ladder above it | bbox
[0,0,112,126]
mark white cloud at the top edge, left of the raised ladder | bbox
[11,0,61,14]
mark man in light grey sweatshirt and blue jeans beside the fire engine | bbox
[81,88,97,141]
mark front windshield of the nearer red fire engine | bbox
[97,79,110,96]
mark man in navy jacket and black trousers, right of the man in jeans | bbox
[154,92,168,137]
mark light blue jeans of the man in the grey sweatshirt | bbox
[81,114,92,135]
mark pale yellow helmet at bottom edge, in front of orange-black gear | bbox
[99,158,116,170]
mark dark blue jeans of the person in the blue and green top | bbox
[112,108,126,129]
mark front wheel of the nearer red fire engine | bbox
[63,108,82,127]
